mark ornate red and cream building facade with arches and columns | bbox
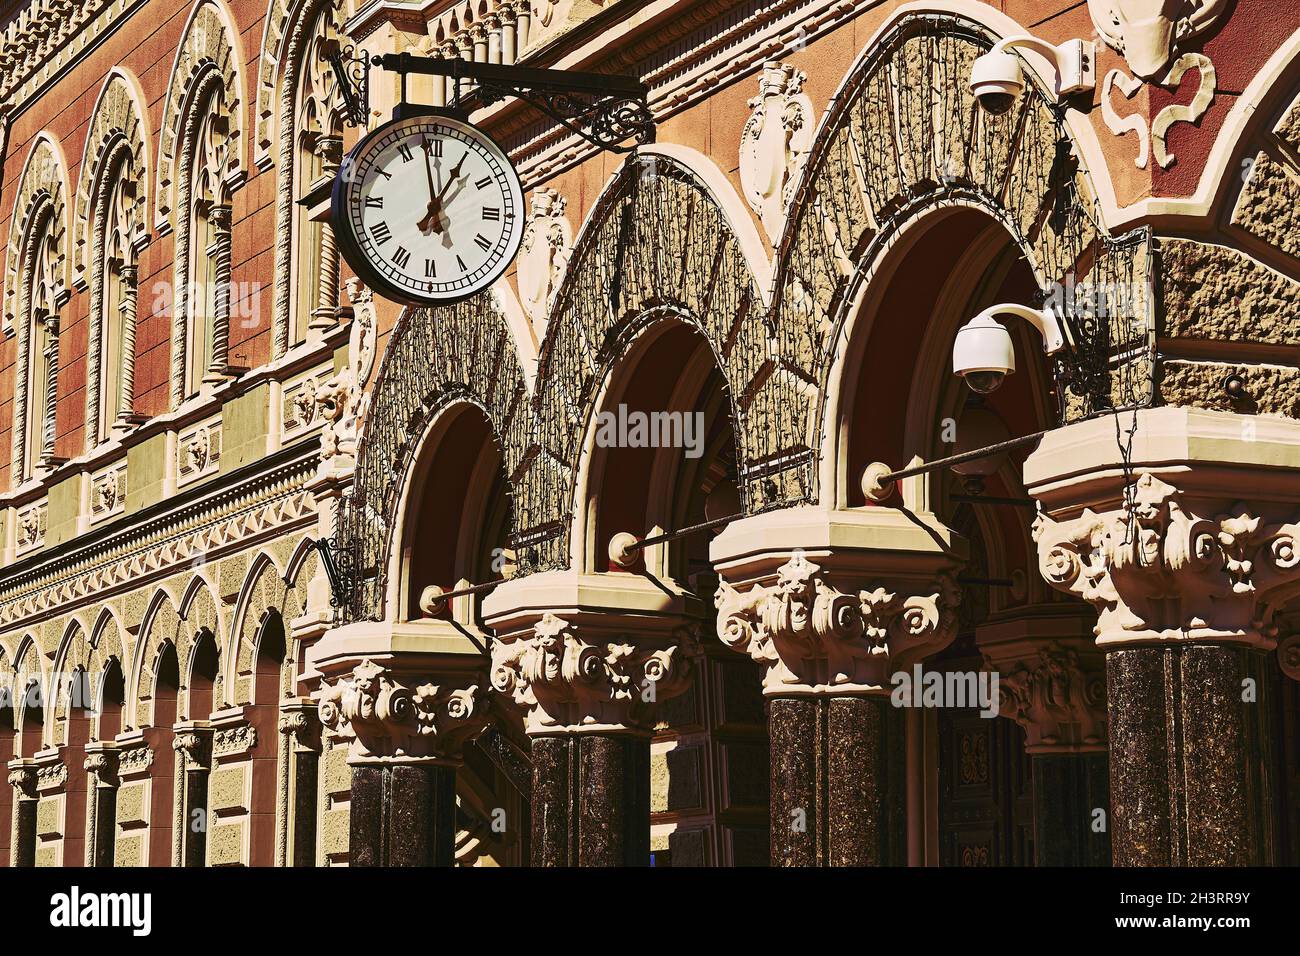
[0,0,1300,866]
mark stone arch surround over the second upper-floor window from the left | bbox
[72,66,151,289]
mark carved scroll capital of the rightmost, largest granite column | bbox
[1034,473,1300,649]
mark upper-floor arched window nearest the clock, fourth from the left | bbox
[280,1,343,347]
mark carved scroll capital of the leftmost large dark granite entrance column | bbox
[317,661,489,763]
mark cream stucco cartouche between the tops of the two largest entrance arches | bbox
[740,62,815,242]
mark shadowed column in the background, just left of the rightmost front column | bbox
[976,606,1110,866]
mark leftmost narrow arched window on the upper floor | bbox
[14,206,62,481]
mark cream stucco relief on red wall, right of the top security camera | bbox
[1088,0,1229,169]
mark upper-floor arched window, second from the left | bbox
[91,148,138,440]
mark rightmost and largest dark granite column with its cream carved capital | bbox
[1024,407,1300,866]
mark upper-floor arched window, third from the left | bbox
[177,75,230,398]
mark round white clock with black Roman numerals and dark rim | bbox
[332,116,524,306]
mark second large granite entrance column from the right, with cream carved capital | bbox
[710,509,963,866]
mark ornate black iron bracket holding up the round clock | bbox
[329,47,655,152]
